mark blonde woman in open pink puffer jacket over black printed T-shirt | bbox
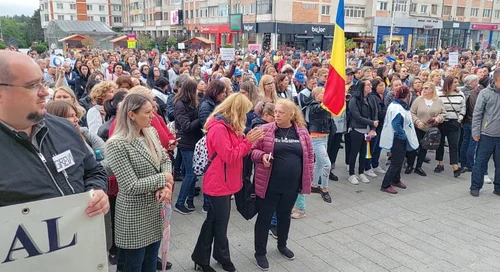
[252,99,314,270]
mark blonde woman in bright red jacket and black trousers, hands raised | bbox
[191,93,264,272]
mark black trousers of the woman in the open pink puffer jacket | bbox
[254,190,298,255]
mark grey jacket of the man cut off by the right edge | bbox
[472,85,500,137]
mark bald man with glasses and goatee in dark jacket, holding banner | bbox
[0,51,109,212]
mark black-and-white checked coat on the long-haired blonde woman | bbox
[106,128,172,249]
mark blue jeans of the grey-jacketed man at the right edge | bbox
[470,135,500,191]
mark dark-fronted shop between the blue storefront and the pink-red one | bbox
[441,21,470,48]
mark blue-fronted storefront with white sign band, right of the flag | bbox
[373,17,443,51]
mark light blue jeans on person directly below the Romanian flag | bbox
[312,136,332,188]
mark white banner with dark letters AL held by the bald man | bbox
[0,193,108,272]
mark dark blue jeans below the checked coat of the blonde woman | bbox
[118,241,160,272]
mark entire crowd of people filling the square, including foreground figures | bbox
[0,44,500,272]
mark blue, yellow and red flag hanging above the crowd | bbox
[323,0,345,116]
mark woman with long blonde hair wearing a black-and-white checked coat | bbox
[106,94,174,271]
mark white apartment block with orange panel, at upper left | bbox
[40,0,123,29]
